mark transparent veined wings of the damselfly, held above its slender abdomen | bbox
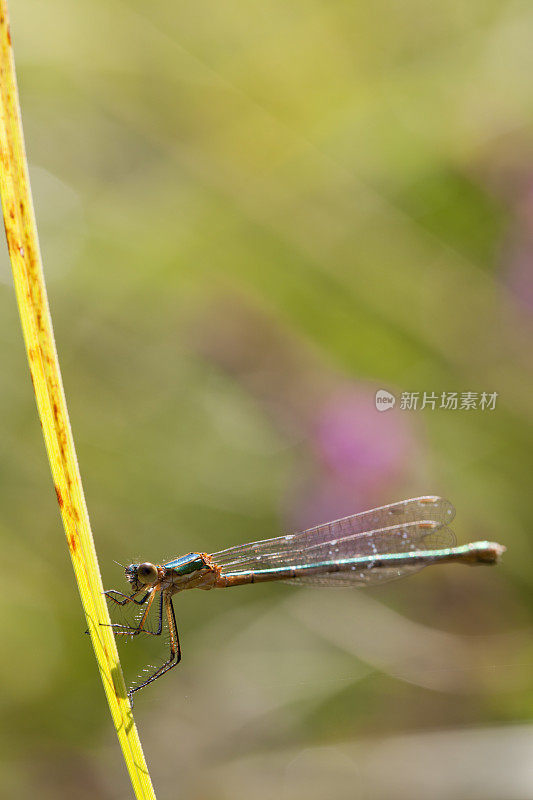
[211,497,455,585]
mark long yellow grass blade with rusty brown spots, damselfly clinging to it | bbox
[0,0,155,798]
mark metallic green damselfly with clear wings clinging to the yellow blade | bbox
[105,496,506,703]
